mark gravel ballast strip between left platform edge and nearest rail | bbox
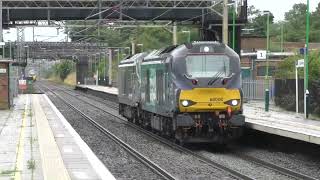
[48,91,162,180]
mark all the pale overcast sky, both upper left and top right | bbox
[4,0,320,42]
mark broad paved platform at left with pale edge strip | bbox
[0,94,115,180]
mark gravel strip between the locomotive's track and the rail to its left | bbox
[47,84,238,179]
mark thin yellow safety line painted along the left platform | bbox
[14,95,29,180]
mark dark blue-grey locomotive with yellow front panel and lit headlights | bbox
[118,42,244,143]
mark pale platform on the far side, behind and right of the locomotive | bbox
[76,85,320,145]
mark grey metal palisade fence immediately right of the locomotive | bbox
[242,80,274,101]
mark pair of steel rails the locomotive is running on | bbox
[38,81,316,180]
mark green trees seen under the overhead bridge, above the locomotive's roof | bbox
[67,21,199,52]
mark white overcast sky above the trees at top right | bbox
[248,0,320,21]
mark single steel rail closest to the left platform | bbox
[38,83,176,180]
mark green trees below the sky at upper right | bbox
[245,3,320,43]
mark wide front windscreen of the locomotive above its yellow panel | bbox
[186,55,230,78]
